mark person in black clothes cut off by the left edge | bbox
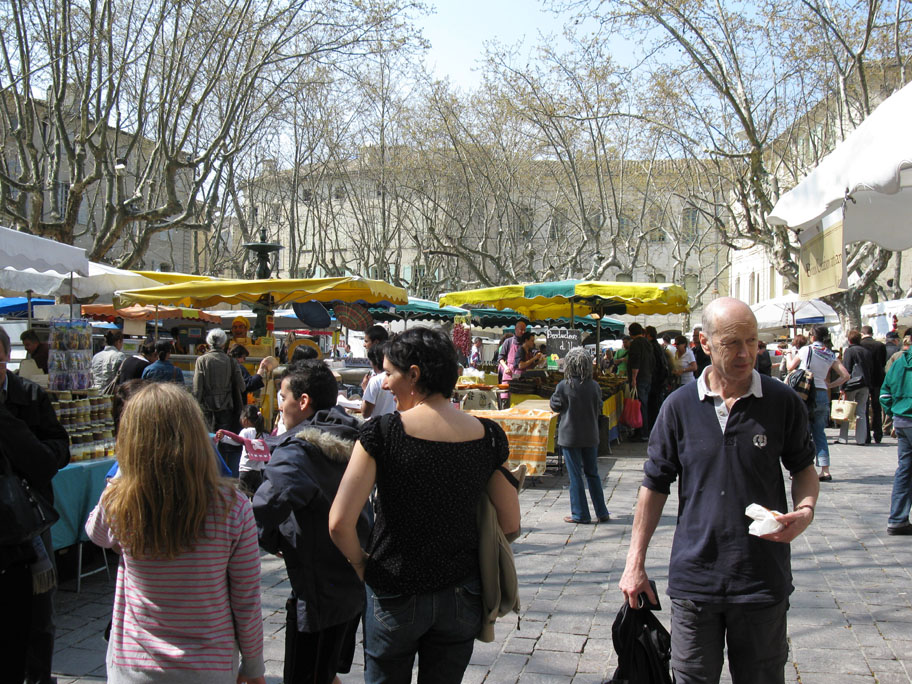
[0,328,70,684]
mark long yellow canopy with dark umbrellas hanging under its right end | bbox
[114,276,408,308]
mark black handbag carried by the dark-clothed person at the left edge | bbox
[0,457,60,546]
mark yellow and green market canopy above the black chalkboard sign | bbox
[440,280,689,320]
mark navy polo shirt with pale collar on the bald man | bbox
[643,375,814,603]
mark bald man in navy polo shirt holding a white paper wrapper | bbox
[619,298,819,684]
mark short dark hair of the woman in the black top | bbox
[385,328,459,397]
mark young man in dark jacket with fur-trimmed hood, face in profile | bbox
[253,360,369,684]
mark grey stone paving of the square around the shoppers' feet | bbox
[54,430,912,684]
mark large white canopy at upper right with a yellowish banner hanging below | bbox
[767,84,912,251]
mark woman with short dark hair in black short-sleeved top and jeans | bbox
[329,328,519,684]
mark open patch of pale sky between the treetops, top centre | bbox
[419,0,562,89]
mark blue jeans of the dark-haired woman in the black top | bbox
[364,577,482,684]
